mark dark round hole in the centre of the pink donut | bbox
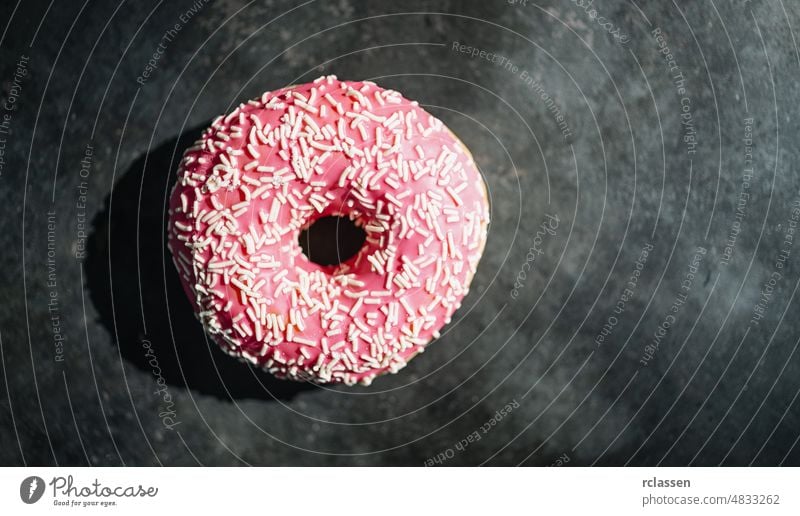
[298,215,367,265]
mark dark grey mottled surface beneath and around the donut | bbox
[0,0,800,465]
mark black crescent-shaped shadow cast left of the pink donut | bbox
[84,122,317,401]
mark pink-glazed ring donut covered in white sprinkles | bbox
[167,75,489,385]
